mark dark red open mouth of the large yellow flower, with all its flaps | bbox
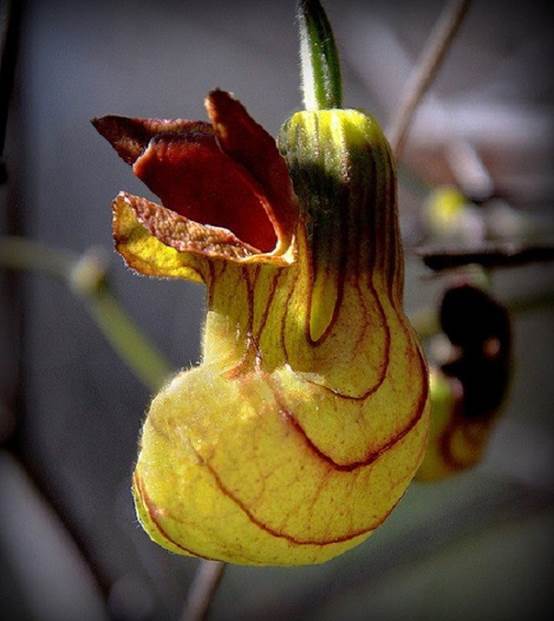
[92,90,298,267]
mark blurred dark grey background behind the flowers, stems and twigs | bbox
[0,0,554,621]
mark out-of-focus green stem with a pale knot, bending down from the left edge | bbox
[0,237,172,391]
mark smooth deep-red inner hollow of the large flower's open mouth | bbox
[133,134,277,252]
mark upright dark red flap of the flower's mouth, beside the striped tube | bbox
[206,90,298,243]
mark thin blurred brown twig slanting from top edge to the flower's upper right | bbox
[389,0,470,159]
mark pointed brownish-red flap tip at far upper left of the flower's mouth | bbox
[91,115,213,164]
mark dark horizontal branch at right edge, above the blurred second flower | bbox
[417,244,554,272]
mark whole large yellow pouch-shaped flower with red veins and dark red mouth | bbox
[94,91,429,565]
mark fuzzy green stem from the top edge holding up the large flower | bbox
[297,0,342,110]
